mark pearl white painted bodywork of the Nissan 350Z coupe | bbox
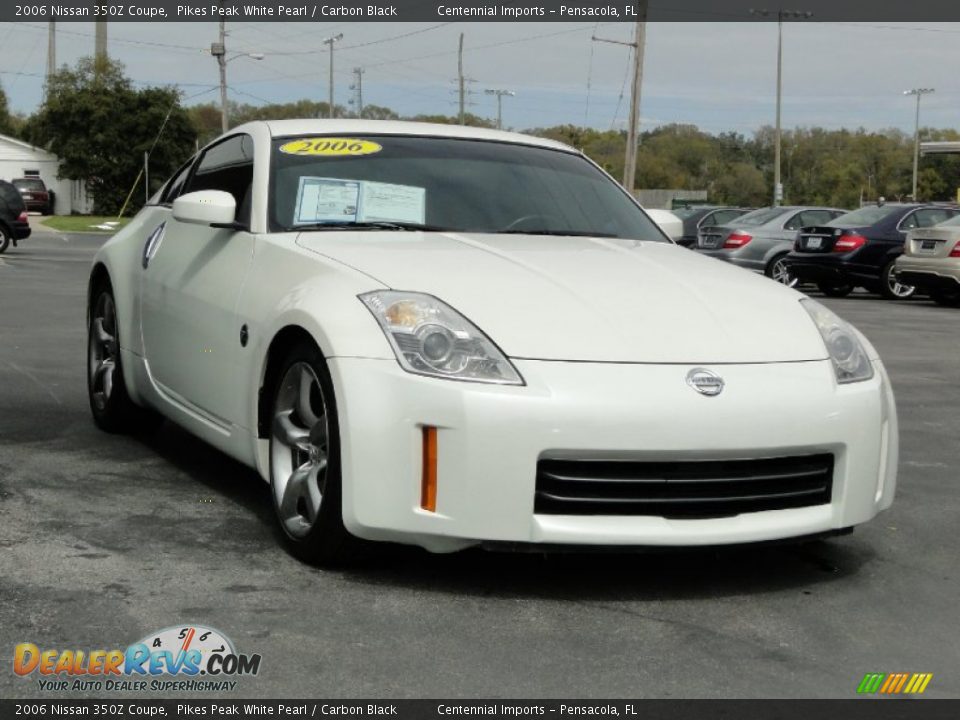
[94,120,898,551]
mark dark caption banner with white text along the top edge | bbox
[9,0,960,22]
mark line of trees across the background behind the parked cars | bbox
[0,58,960,214]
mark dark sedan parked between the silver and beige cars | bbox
[785,203,960,299]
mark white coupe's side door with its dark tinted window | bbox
[140,134,254,428]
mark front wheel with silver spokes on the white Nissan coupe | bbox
[266,341,368,566]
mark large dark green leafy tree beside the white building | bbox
[27,58,197,214]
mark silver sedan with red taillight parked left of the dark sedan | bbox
[695,206,847,285]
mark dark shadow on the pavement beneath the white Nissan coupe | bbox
[133,422,874,601]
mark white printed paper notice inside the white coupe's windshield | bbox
[294,177,427,225]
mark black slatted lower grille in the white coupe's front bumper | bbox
[534,453,833,518]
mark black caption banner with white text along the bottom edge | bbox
[0,698,960,720]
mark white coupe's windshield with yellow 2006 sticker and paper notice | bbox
[269,135,669,242]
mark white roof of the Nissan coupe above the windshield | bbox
[251,119,580,154]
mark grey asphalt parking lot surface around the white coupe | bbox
[0,232,960,698]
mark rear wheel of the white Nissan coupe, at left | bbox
[87,283,162,433]
